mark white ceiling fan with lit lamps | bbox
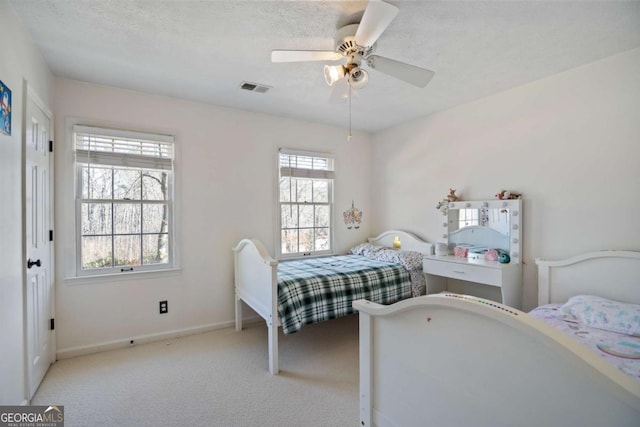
[271,0,434,101]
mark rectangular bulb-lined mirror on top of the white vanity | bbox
[442,199,522,263]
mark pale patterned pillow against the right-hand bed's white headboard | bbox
[559,295,640,336]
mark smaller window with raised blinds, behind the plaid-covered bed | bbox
[278,149,333,257]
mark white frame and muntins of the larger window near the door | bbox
[69,124,178,278]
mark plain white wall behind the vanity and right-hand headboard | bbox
[372,49,640,309]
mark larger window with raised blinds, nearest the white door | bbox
[73,126,174,275]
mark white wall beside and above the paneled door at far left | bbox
[0,0,51,405]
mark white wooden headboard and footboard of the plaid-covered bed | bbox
[233,230,433,375]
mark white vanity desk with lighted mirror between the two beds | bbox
[423,200,522,309]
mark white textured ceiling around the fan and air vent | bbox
[11,0,640,132]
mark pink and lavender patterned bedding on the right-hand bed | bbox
[529,304,640,382]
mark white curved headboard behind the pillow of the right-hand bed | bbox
[536,251,640,305]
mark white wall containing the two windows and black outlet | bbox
[54,79,371,357]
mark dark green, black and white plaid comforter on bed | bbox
[278,255,411,334]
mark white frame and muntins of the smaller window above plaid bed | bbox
[275,148,335,259]
